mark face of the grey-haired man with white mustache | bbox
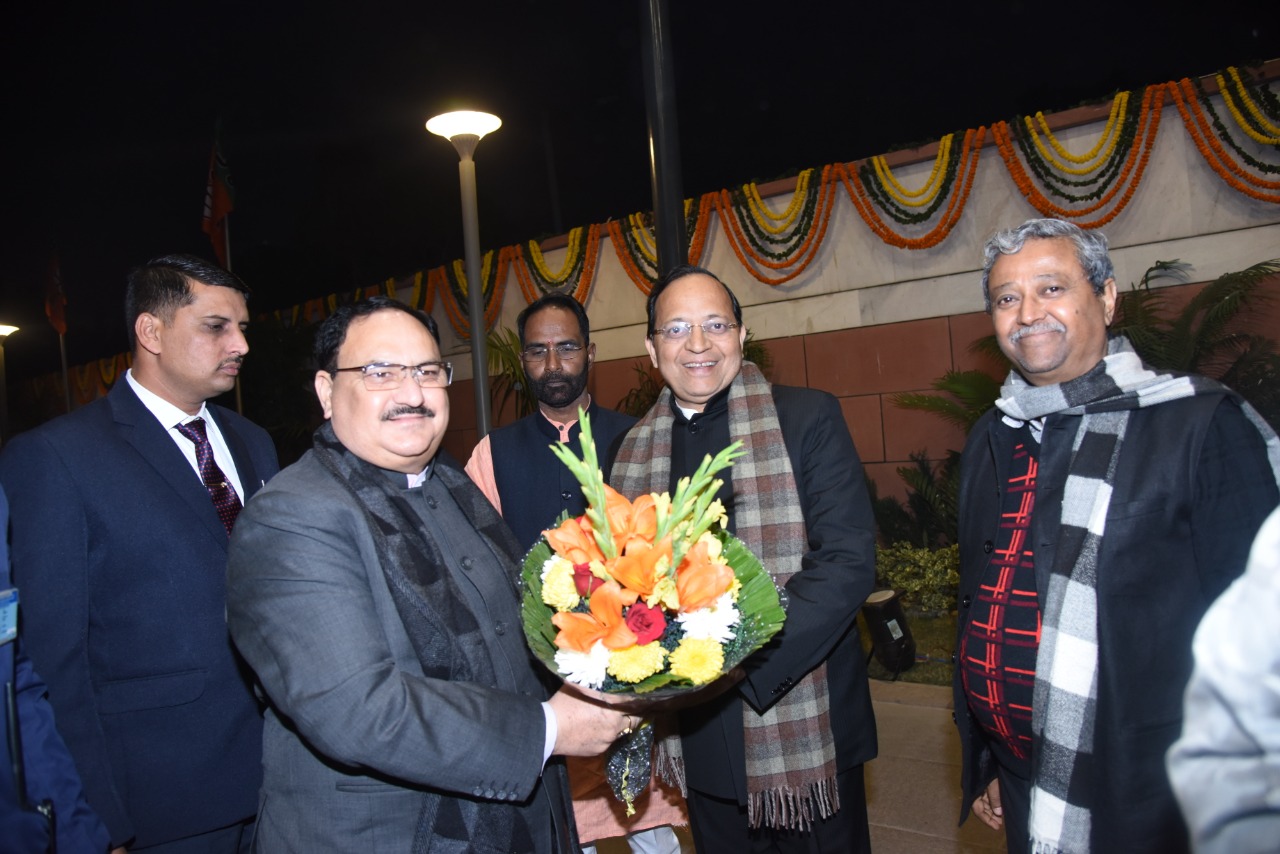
[989,238,1116,385]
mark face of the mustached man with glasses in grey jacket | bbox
[316,310,449,474]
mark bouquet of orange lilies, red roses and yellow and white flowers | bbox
[522,410,786,812]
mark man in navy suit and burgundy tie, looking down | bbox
[0,255,278,851]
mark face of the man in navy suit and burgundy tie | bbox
[133,282,248,415]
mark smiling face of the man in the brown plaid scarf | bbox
[645,273,746,412]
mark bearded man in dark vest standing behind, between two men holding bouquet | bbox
[467,293,635,549]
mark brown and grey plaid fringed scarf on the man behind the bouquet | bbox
[611,362,840,831]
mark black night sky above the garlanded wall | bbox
[0,0,1280,382]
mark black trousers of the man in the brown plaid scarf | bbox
[687,766,872,854]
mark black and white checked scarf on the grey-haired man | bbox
[996,335,1280,854]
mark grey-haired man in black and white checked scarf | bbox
[955,219,1280,853]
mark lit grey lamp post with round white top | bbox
[426,110,502,438]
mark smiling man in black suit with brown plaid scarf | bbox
[609,266,876,854]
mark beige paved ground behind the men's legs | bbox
[598,680,1005,854]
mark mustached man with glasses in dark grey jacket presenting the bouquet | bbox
[228,297,636,854]
